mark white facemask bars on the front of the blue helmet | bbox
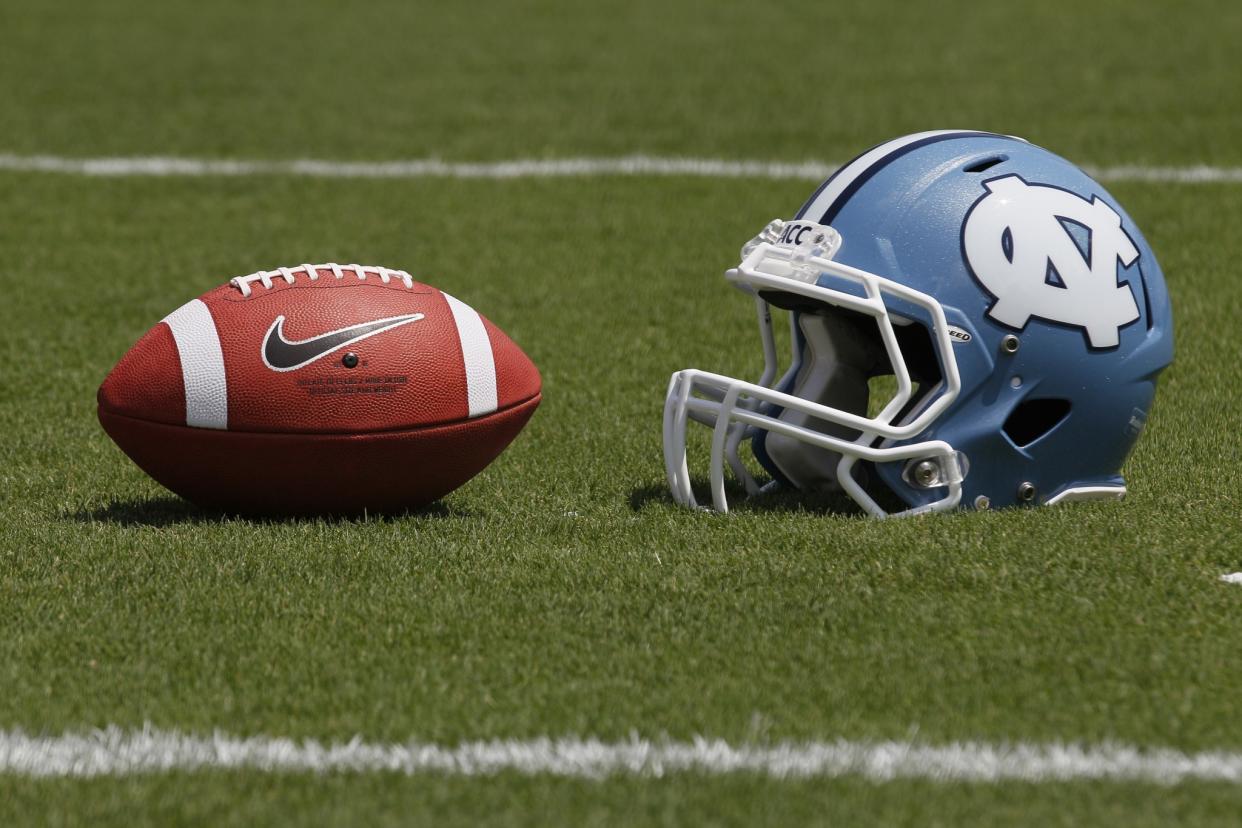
[663,221,965,516]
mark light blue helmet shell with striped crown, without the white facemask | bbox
[754,132,1172,506]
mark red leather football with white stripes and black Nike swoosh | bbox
[98,264,540,514]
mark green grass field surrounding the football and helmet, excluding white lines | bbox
[0,0,1242,826]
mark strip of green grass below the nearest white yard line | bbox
[7,773,1237,828]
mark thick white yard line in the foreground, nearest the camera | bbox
[0,726,1242,785]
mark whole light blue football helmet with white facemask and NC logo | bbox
[664,130,1172,516]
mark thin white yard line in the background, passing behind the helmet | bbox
[0,154,1242,184]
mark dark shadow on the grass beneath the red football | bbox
[61,495,473,526]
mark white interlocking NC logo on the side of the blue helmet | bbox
[961,175,1139,348]
